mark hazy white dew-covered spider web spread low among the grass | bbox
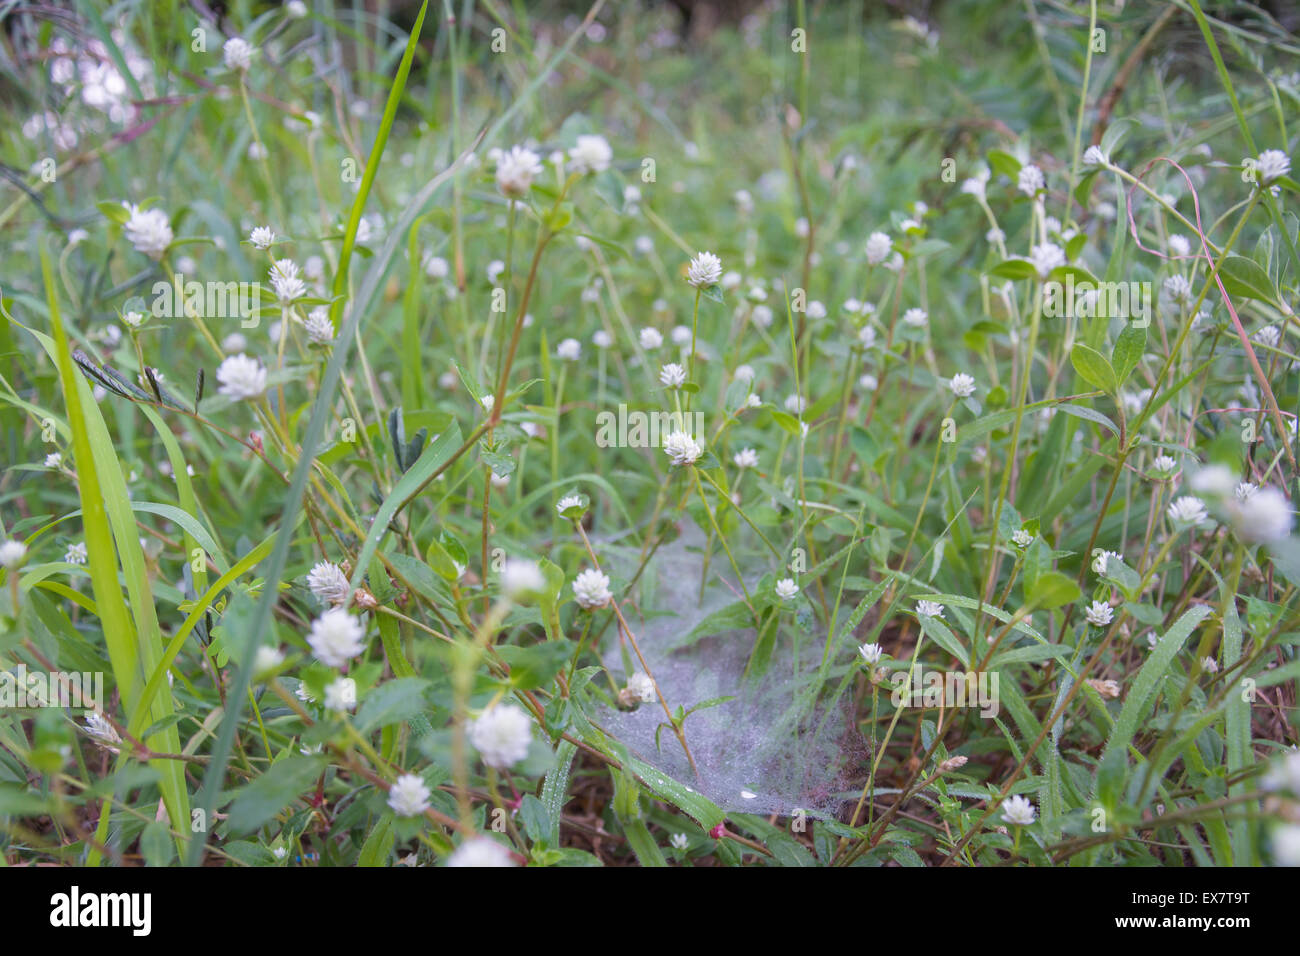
[593,523,867,816]
